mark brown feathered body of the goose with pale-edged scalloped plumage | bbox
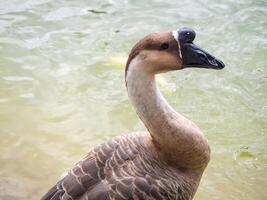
[42,133,197,200]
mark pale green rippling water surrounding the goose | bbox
[0,0,267,200]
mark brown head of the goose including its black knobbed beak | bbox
[126,28,225,75]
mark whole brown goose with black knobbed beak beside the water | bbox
[41,27,225,200]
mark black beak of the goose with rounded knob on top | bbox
[178,28,225,69]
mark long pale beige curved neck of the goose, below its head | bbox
[126,59,209,168]
